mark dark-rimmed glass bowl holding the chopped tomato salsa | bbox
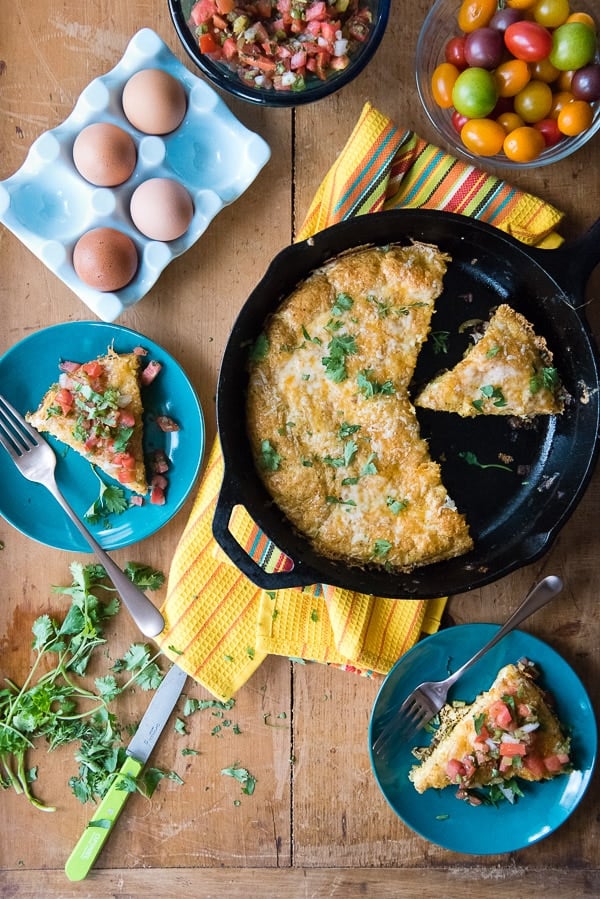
[169,0,391,108]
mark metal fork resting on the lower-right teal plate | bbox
[373,575,563,755]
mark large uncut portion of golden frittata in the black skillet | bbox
[247,243,472,570]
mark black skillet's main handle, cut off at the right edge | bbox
[531,218,600,303]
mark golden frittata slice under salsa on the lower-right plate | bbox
[409,665,569,793]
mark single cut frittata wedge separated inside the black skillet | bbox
[415,304,563,418]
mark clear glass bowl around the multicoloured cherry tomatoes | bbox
[416,0,600,169]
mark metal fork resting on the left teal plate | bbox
[0,395,165,637]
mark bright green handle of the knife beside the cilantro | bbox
[65,756,144,880]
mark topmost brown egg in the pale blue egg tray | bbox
[122,69,187,134]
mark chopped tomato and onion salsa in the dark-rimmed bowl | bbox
[189,0,373,91]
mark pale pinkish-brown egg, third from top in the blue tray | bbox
[130,178,194,241]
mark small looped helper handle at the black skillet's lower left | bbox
[212,471,319,590]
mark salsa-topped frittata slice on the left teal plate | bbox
[26,349,148,494]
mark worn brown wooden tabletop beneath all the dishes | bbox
[0,0,600,899]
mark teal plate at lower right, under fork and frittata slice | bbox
[369,624,598,855]
